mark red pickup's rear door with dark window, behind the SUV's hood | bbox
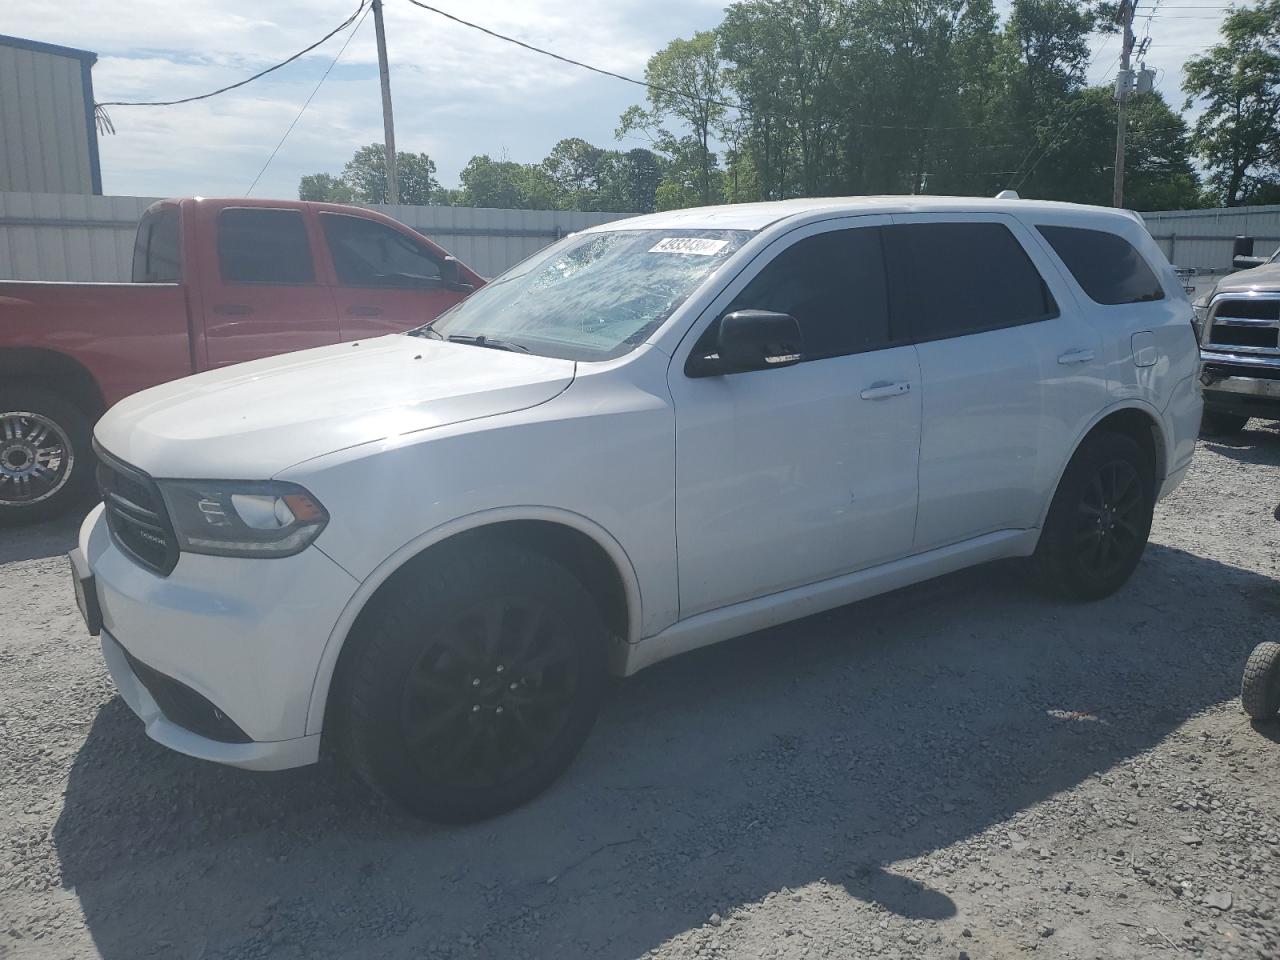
[188,204,340,367]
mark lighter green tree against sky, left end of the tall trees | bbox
[617,31,724,204]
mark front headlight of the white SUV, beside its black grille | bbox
[156,480,329,557]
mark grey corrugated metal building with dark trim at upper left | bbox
[0,35,102,193]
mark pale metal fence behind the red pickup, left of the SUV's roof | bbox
[0,193,630,282]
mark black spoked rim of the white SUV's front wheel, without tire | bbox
[401,598,579,787]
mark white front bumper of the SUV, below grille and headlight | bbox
[79,507,357,769]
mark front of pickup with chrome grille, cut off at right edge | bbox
[1194,250,1280,436]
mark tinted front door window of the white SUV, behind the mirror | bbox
[712,227,888,360]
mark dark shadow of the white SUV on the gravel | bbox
[52,545,1275,960]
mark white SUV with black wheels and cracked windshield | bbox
[72,197,1201,820]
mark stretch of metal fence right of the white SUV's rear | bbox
[1142,206,1280,273]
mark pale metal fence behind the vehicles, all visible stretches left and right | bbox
[0,193,1280,282]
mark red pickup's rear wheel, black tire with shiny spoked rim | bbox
[0,383,93,526]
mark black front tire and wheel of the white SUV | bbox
[335,541,608,823]
